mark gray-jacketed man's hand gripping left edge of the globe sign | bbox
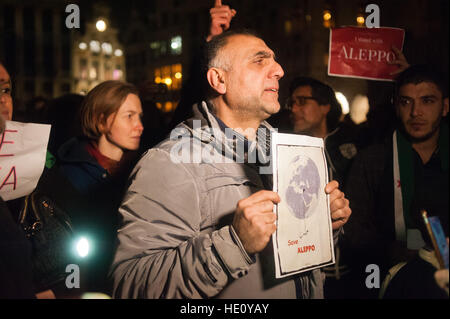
[233,190,280,254]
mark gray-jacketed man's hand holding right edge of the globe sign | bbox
[325,181,352,230]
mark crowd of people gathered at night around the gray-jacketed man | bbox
[0,0,449,299]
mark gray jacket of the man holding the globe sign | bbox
[110,102,323,299]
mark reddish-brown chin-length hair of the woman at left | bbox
[81,81,139,140]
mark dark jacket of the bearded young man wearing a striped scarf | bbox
[342,131,448,273]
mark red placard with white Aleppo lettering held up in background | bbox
[328,27,405,81]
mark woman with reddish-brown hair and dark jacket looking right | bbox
[58,81,144,293]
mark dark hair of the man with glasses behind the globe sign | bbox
[289,76,342,132]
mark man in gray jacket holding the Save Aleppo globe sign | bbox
[111,32,351,299]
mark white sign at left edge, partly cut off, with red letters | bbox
[0,121,51,201]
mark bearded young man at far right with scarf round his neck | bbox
[344,65,449,296]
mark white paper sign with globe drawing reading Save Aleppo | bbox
[271,132,335,278]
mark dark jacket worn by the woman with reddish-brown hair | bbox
[58,138,131,293]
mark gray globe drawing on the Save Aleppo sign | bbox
[285,155,320,237]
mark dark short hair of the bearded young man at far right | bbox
[394,64,448,98]
